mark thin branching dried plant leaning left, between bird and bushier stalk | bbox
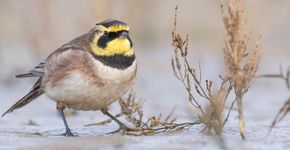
[171,7,233,135]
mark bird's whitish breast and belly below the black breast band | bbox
[45,62,136,110]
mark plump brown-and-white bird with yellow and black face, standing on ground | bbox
[2,19,137,136]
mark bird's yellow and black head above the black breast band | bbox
[90,20,134,57]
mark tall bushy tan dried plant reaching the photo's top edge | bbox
[221,0,260,139]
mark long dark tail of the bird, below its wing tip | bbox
[2,77,44,117]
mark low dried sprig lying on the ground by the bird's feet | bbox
[85,89,200,136]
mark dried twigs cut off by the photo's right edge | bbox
[258,65,290,130]
